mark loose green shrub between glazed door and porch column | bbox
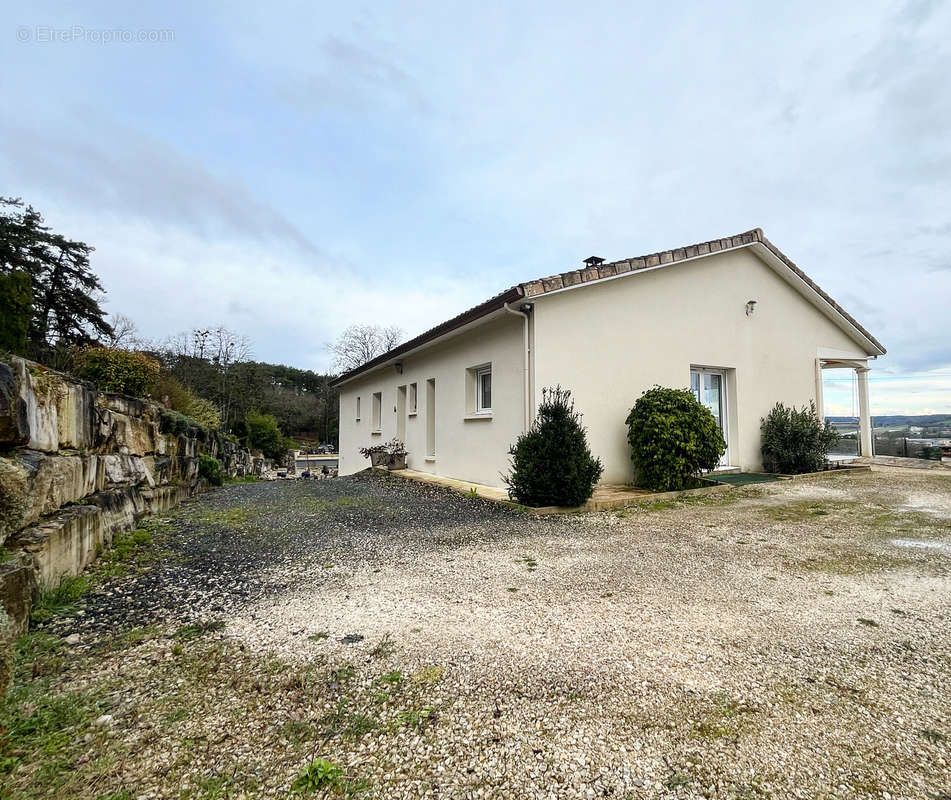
[760,401,839,475]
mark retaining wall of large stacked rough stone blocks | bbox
[0,357,266,632]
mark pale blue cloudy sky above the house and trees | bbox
[0,0,951,414]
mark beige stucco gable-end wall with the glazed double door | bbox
[533,249,867,483]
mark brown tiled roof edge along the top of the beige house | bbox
[334,228,885,385]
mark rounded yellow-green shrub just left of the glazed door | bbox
[627,386,726,492]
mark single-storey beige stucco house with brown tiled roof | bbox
[335,228,885,486]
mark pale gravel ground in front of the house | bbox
[9,469,951,800]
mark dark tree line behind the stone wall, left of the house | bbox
[0,197,402,452]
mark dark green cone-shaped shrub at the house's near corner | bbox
[503,386,604,506]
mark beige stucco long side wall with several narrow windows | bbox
[340,312,524,486]
